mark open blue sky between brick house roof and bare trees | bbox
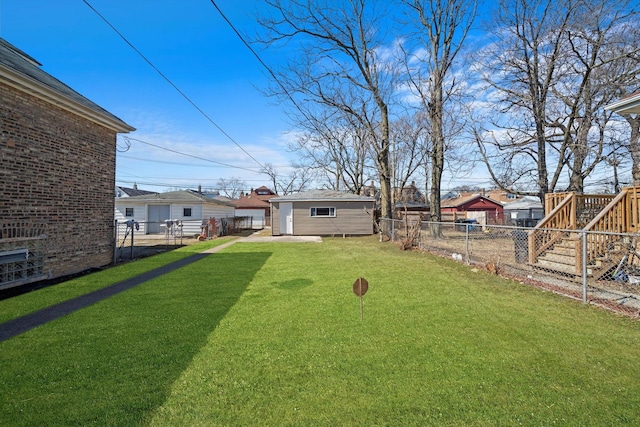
[0,0,291,191]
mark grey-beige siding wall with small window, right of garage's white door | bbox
[292,201,373,236]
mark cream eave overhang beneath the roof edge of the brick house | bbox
[0,64,136,133]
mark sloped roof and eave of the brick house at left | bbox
[0,38,135,132]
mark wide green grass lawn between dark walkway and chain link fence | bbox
[0,238,640,426]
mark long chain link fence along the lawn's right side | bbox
[380,219,640,316]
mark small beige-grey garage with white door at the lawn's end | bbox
[269,190,375,236]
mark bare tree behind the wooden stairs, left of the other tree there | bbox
[475,0,573,203]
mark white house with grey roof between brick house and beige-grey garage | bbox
[115,190,235,236]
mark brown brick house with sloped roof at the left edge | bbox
[0,38,135,289]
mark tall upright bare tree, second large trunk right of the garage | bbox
[404,0,477,227]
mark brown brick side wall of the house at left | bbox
[0,83,116,277]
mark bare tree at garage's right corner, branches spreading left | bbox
[260,0,394,218]
